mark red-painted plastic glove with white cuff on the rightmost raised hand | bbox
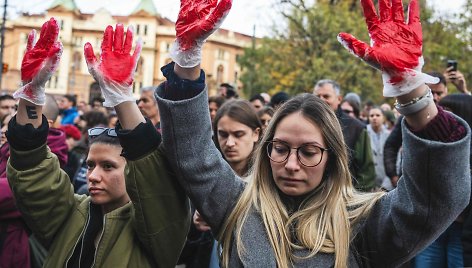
[338,0,439,97]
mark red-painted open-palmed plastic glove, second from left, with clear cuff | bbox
[84,24,142,107]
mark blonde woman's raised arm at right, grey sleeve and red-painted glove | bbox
[338,0,470,267]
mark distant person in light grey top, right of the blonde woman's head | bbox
[367,106,393,191]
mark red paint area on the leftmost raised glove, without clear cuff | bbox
[21,18,60,83]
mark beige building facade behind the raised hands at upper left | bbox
[1,0,252,102]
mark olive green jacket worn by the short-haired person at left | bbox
[7,145,190,267]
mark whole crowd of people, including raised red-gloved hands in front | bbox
[0,0,472,268]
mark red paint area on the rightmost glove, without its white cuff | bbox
[340,0,423,84]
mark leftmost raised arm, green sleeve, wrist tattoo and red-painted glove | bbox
[7,18,81,244]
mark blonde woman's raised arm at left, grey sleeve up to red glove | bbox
[156,0,244,233]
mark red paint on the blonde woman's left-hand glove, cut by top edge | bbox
[175,0,232,51]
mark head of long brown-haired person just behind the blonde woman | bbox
[213,100,262,177]
